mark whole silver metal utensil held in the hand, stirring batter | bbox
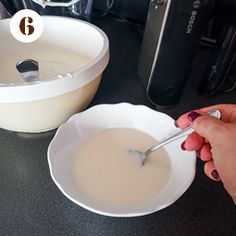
[129,110,221,165]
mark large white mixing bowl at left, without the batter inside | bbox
[0,16,109,132]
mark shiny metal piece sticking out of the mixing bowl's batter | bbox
[16,59,39,83]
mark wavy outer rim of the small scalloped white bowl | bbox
[47,102,196,217]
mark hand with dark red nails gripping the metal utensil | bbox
[175,104,236,204]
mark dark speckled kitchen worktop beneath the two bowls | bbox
[0,16,236,236]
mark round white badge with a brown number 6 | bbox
[10,9,43,43]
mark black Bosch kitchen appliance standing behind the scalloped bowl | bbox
[138,0,236,106]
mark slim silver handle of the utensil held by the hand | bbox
[144,110,221,157]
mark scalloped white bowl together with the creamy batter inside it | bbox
[48,103,196,217]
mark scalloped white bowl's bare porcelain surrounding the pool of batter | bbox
[48,103,196,217]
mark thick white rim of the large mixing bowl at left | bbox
[0,16,110,103]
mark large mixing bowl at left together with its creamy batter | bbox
[0,16,109,132]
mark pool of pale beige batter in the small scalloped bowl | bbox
[72,128,171,206]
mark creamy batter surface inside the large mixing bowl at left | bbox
[0,42,91,84]
